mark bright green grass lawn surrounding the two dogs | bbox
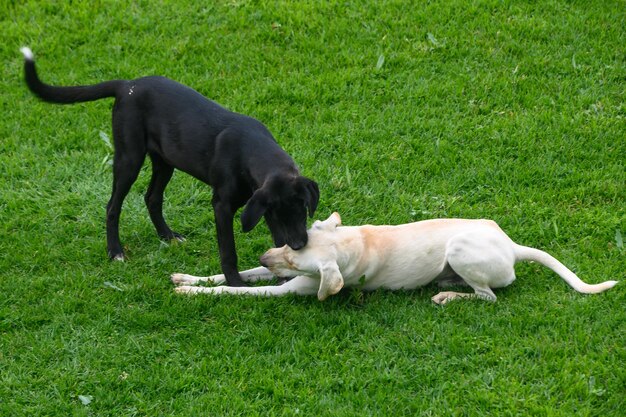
[0,0,626,416]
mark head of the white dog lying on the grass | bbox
[261,212,343,301]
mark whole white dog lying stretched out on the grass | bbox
[172,213,617,304]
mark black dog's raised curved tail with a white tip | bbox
[20,47,127,104]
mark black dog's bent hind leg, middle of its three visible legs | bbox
[145,153,185,242]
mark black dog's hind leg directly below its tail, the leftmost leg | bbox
[106,112,146,261]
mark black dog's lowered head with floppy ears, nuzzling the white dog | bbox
[241,176,320,250]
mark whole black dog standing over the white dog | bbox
[22,48,319,286]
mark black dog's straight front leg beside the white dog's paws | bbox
[213,198,246,287]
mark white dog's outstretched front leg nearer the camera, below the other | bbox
[175,276,320,297]
